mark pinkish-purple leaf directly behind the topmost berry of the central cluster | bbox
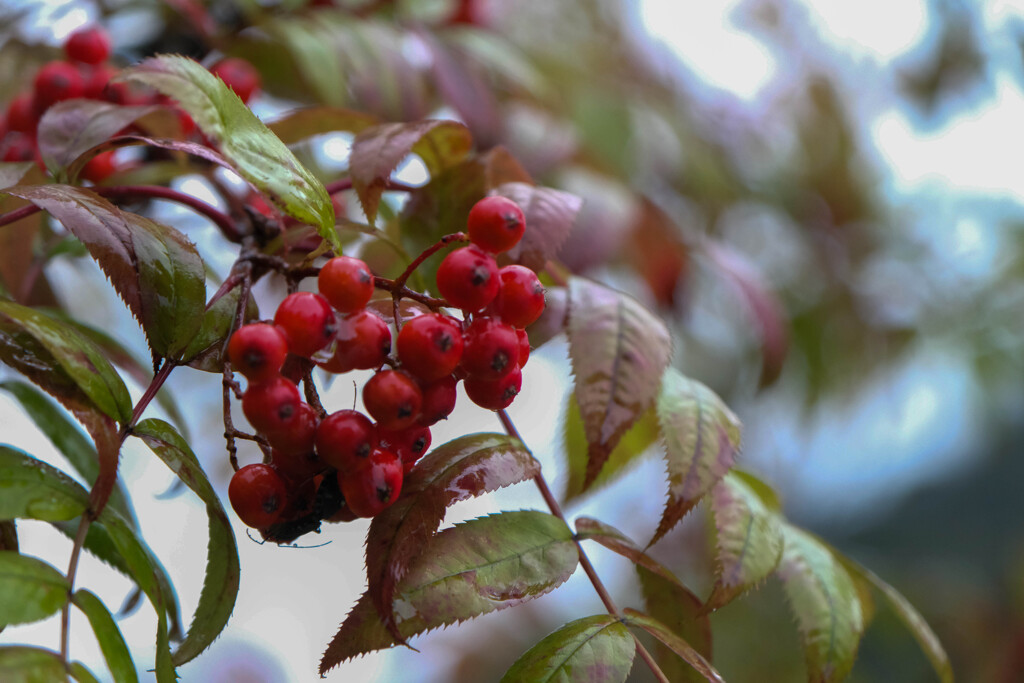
[495,182,583,270]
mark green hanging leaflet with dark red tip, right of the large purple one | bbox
[651,368,740,545]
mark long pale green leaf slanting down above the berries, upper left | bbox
[122,54,341,248]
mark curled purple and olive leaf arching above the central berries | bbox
[348,120,473,225]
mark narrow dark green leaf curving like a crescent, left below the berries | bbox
[132,419,241,666]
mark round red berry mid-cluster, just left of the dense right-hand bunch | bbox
[398,313,463,382]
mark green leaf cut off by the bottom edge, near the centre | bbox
[501,614,636,683]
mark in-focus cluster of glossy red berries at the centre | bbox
[227,197,545,540]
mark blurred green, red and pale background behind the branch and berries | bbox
[0,0,1024,683]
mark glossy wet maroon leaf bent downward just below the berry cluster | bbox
[367,434,541,634]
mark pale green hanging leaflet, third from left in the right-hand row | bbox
[706,472,783,611]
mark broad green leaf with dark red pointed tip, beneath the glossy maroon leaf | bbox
[319,510,580,675]
